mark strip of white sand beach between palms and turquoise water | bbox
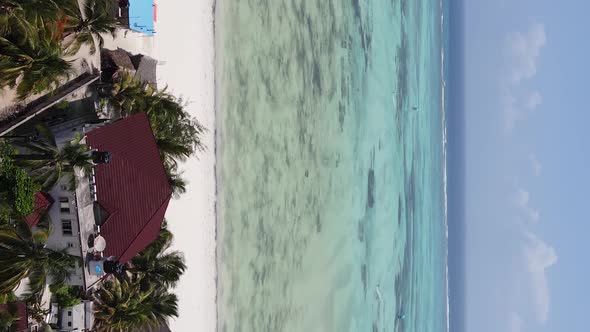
[154,0,217,331]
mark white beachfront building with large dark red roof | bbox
[32,113,172,290]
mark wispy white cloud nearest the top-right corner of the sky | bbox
[508,23,547,84]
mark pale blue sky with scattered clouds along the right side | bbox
[464,0,590,332]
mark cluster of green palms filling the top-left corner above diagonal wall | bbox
[0,0,117,100]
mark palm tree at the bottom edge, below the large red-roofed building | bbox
[93,278,178,332]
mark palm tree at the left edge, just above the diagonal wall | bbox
[0,22,72,100]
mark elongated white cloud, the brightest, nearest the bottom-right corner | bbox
[524,232,557,323]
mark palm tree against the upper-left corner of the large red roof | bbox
[12,124,92,191]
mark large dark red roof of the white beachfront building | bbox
[86,113,172,263]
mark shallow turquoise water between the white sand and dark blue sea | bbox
[216,0,447,332]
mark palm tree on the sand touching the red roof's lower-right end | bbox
[127,223,186,289]
